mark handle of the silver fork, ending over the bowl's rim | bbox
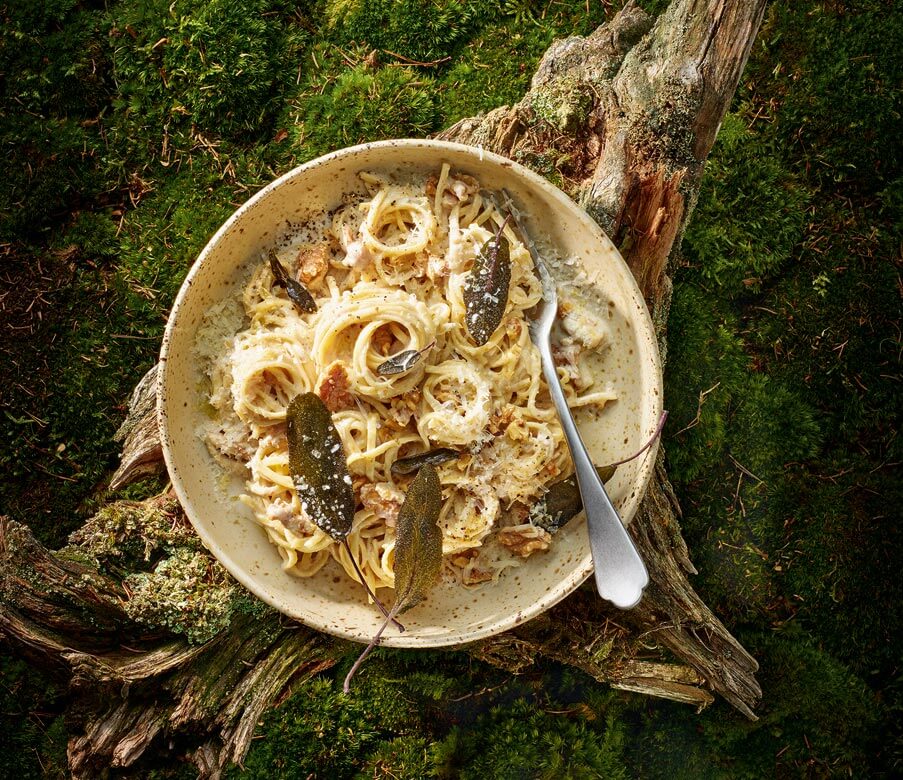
[539,348,649,609]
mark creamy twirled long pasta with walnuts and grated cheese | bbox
[198,165,614,589]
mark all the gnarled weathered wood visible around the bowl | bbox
[0,0,765,777]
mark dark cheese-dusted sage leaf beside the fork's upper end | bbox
[464,214,511,347]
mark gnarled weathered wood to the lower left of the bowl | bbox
[0,517,349,778]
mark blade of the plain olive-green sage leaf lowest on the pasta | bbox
[392,465,442,613]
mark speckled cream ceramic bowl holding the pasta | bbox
[157,140,662,647]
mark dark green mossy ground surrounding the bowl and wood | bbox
[0,0,903,778]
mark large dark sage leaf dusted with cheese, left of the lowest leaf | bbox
[286,393,354,542]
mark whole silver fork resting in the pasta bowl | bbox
[503,191,649,609]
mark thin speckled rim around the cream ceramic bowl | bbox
[157,138,663,648]
